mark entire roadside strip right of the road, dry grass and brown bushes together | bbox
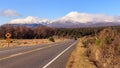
[66,27,120,68]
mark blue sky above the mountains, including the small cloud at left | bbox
[0,0,120,24]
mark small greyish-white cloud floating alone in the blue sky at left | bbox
[0,9,20,17]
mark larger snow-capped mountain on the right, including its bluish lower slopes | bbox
[50,12,120,27]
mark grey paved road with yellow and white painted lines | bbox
[0,40,77,68]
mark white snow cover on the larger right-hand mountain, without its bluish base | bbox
[53,12,120,23]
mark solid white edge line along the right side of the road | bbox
[42,42,77,68]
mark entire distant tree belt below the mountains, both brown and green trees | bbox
[0,24,120,39]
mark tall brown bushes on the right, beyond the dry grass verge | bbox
[83,28,120,68]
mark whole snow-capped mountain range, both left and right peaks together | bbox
[8,12,120,27]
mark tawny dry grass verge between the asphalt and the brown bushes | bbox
[66,41,96,68]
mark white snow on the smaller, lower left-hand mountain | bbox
[8,16,50,24]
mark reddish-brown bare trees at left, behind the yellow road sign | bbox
[0,25,55,39]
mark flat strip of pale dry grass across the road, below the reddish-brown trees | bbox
[0,39,66,48]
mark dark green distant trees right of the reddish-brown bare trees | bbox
[56,27,103,38]
